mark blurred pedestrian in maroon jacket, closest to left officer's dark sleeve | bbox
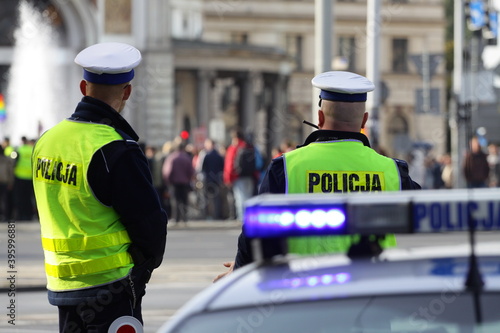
[162,141,194,223]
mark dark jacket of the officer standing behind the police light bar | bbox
[234,130,421,268]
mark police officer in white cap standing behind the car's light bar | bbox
[215,71,420,281]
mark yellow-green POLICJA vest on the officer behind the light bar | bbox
[283,140,401,254]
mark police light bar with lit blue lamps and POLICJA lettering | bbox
[243,189,500,238]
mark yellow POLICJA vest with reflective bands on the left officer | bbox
[33,120,133,291]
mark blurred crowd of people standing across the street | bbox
[0,130,500,223]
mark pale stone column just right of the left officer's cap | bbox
[131,0,176,147]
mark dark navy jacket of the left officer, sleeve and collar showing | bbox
[45,96,167,306]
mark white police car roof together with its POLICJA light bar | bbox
[159,190,500,330]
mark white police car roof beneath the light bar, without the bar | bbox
[159,242,500,327]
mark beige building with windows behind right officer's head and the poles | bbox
[202,0,447,157]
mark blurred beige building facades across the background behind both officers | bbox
[0,0,447,158]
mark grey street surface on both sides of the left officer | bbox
[0,221,240,333]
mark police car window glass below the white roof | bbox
[171,290,500,333]
